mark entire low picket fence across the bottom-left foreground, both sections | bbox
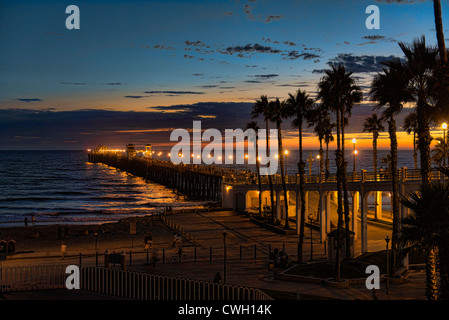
[0,265,271,300]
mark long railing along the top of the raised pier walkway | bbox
[223,168,447,185]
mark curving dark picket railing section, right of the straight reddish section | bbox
[81,267,271,300]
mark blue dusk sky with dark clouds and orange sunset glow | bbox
[0,0,449,150]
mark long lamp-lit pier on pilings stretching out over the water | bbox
[88,145,446,252]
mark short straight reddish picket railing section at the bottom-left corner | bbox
[0,265,66,292]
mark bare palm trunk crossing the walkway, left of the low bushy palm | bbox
[388,117,400,272]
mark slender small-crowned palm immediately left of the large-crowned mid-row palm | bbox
[286,89,314,262]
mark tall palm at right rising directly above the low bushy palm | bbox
[399,36,438,183]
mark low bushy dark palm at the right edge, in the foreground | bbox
[398,181,449,300]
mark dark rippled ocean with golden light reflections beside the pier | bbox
[0,150,413,226]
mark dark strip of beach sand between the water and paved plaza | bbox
[0,215,175,259]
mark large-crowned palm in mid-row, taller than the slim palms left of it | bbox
[317,65,362,281]
